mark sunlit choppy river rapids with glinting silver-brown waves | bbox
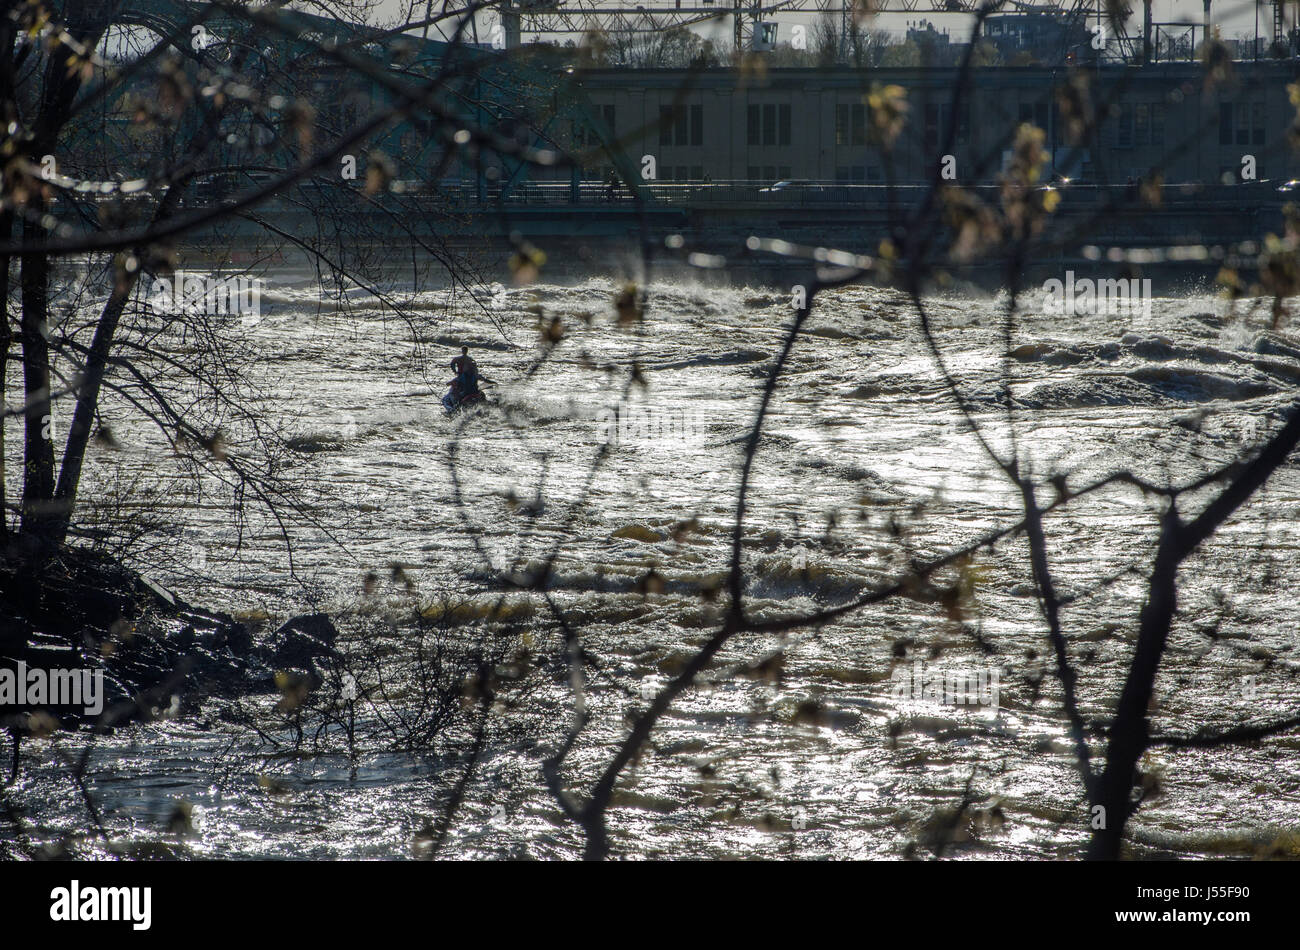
[12,267,1300,858]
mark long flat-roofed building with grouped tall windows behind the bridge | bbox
[560,61,1300,183]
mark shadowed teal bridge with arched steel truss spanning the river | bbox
[45,0,1290,282]
